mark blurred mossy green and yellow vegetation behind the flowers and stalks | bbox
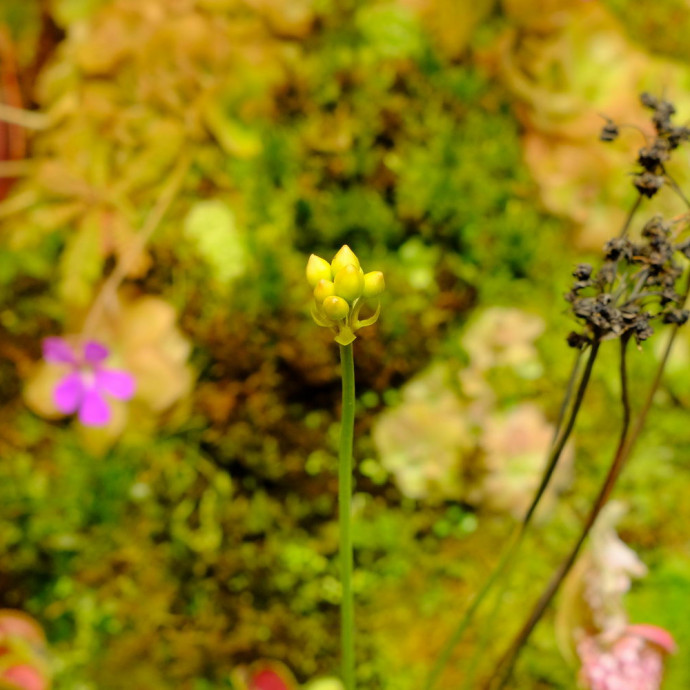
[0,0,690,690]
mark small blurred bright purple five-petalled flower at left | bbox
[43,338,135,426]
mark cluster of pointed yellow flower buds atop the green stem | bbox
[307,245,386,345]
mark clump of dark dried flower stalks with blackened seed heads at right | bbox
[424,93,690,690]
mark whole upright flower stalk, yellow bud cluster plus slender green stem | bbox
[307,245,385,690]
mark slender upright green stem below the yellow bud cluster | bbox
[338,343,355,690]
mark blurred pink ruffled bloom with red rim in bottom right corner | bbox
[577,625,675,690]
